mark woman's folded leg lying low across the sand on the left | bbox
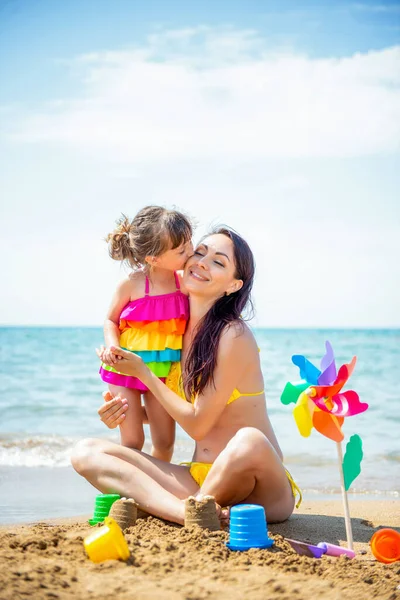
[71,439,199,524]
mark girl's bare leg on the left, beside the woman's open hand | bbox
[109,385,144,450]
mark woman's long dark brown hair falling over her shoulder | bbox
[183,227,255,398]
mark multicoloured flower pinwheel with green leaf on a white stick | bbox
[281,342,368,549]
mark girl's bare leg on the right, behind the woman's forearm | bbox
[144,392,175,462]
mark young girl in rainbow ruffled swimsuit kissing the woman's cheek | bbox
[100,206,193,461]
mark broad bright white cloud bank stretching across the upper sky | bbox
[9,27,400,164]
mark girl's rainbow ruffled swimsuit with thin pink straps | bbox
[100,273,189,392]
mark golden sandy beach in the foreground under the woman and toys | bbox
[0,499,400,600]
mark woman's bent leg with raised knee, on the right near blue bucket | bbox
[200,427,294,523]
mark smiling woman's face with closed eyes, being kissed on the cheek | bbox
[184,233,243,299]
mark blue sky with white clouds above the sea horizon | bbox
[0,0,400,328]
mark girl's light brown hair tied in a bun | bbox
[106,206,193,269]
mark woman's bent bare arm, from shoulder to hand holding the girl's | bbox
[99,327,254,441]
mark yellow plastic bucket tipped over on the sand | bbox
[83,517,130,563]
